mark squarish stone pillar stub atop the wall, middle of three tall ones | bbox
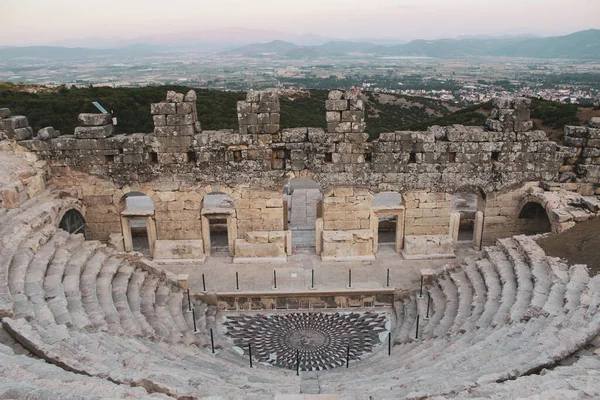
[237,90,280,134]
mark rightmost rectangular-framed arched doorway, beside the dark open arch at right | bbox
[450,187,486,250]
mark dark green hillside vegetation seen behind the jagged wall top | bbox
[0,83,600,140]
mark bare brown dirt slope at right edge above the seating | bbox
[539,218,600,276]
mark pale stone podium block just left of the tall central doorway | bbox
[233,231,292,264]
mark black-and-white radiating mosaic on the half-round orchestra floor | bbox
[224,312,388,371]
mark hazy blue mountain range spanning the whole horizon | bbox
[0,29,600,61]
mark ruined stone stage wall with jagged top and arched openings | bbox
[5,91,600,246]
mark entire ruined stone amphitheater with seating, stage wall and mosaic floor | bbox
[0,91,600,400]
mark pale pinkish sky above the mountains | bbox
[0,0,600,45]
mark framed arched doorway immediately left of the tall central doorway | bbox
[201,192,236,256]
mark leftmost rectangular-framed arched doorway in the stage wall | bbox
[120,192,156,257]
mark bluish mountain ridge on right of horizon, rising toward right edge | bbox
[221,29,600,59]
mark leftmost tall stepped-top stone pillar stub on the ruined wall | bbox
[150,90,202,136]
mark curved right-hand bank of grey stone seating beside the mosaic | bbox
[319,236,600,398]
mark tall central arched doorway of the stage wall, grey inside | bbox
[283,178,323,250]
